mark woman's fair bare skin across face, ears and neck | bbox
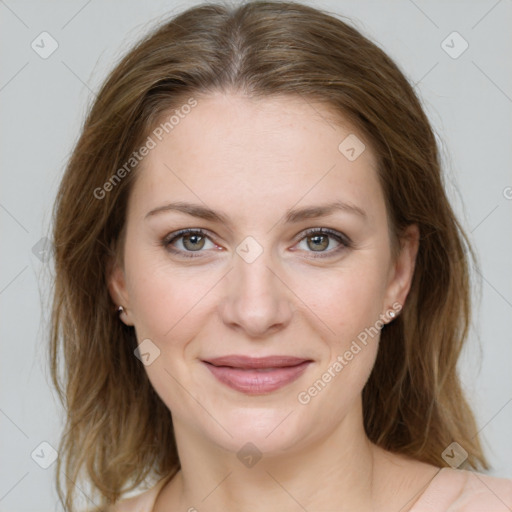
[109,92,438,512]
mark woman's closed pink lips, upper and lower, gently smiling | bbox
[202,355,312,395]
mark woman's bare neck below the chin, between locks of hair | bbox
[162,402,384,512]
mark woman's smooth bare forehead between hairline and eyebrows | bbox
[127,93,384,228]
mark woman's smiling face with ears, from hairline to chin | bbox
[109,93,417,454]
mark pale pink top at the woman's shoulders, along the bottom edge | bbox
[112,468,512,512]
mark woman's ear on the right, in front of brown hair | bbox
[383,224,420,311]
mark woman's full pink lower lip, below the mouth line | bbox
[204,361,311,395]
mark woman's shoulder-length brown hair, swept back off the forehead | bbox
[50,2,489,512]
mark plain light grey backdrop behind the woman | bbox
[0,0,512,512]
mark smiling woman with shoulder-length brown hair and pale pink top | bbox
[51,2,512,512]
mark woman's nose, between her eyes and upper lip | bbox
[219,246,293,339]
